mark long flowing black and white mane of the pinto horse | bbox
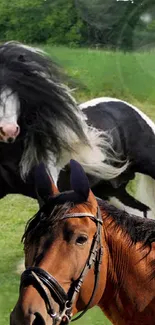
[0,41,127,179]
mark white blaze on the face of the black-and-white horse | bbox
[0,87,20,125]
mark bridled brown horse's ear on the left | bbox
[35,163,59,203]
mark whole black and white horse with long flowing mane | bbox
[0,42,155,215]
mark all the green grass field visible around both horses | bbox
[0,46,155,325]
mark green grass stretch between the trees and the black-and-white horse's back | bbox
[44,46,155,116]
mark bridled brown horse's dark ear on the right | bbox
[70,159,90,201]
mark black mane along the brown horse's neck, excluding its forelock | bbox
[98,200,155,246]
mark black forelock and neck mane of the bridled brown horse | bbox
[23,192,155,251]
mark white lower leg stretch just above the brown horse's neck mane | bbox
[108,197,149,218]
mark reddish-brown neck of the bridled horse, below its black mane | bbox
[99,217,155,325]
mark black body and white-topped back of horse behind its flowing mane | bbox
[80,97,155,177]
